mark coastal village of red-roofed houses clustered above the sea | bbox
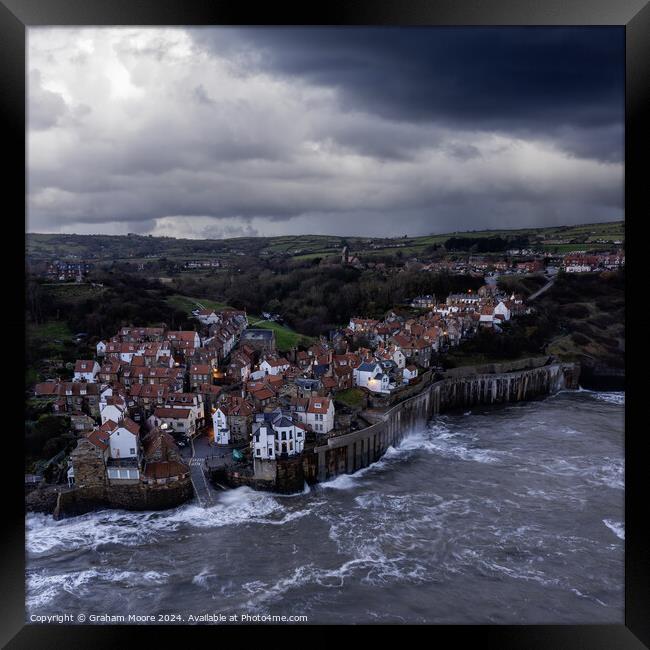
[26,239,624,508]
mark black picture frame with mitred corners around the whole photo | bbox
[0,0,650,650]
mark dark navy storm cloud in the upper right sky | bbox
[193,27,625,160]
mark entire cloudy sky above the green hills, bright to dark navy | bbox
[27,27,624,238]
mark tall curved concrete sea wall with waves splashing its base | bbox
[312,357,580,482]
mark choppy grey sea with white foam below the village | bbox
[27,391,624,624]
